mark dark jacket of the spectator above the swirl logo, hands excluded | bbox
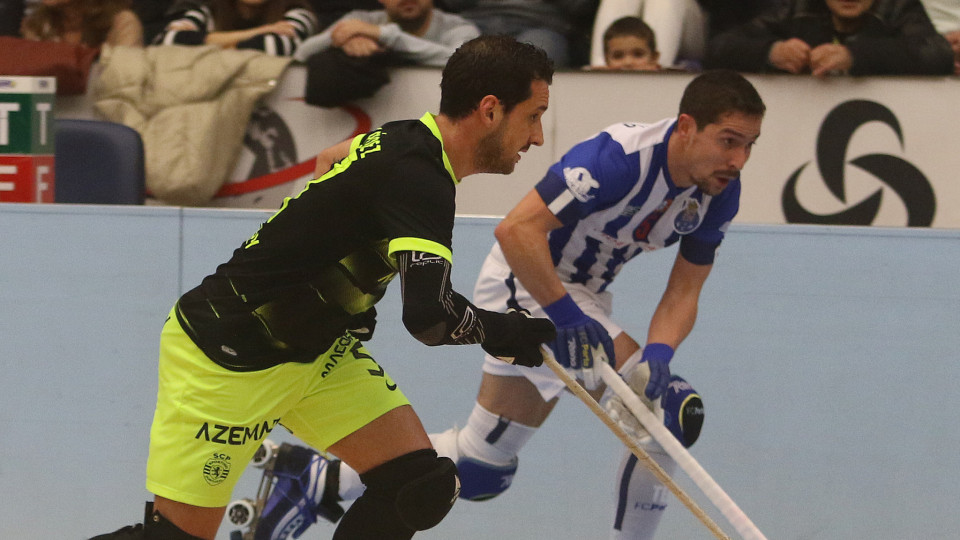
[704,0,953,75]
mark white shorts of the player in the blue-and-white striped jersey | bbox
[473,244,623,401]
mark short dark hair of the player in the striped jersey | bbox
[680,69,767,131]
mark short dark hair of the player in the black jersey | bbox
[440,35,553,119]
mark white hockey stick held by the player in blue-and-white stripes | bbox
[599,362,767,540]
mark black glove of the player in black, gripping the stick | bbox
[481,310,557,367]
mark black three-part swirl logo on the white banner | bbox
[782,100,936,227]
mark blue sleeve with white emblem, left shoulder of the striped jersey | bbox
[536,127,640,225]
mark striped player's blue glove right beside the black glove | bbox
[543,294,616,390]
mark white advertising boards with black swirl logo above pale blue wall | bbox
[56,65,960,228]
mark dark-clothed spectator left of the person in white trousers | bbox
[442,0,609,68]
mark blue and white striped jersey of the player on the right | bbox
[536,119,740,292]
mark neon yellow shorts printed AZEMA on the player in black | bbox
[147,314,410,507]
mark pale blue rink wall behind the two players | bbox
[0,204,960,540]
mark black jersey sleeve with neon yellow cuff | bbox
[378,155,456,263]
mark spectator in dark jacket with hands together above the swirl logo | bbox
[705,0,953,77]
